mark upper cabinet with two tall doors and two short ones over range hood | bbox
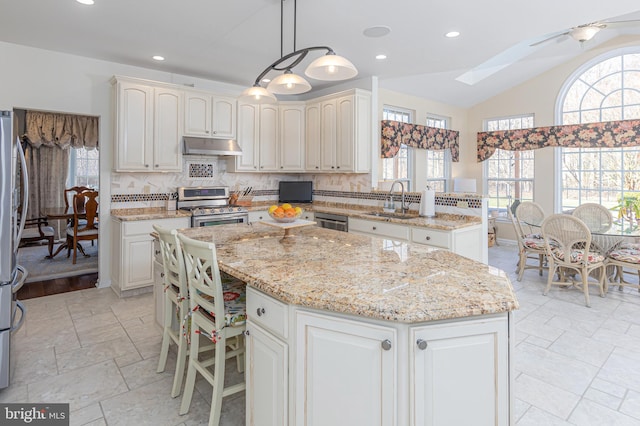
[111,76,237,172]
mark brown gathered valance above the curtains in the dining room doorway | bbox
[24,111,100,149]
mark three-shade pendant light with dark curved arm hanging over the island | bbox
[238,0,358,103]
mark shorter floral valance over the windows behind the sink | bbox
[381,120,460,162]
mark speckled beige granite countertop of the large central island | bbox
[180,223,518,323]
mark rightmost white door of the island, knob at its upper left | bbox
[409,314,509,426]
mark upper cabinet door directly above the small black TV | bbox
[279,105,305,172]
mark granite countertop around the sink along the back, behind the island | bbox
[248,203,482,231]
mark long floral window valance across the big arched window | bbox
[478,120,640,162]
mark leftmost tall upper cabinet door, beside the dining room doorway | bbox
[116,82,153,171]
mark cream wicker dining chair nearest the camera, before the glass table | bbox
[542,214,607,307]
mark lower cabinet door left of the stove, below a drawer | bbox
[121,235,154,290]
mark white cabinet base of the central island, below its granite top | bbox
[246,288,512,426]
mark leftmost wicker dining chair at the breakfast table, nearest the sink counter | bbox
[507,201,546,281]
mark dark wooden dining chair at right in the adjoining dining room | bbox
[67,191,98,264]
